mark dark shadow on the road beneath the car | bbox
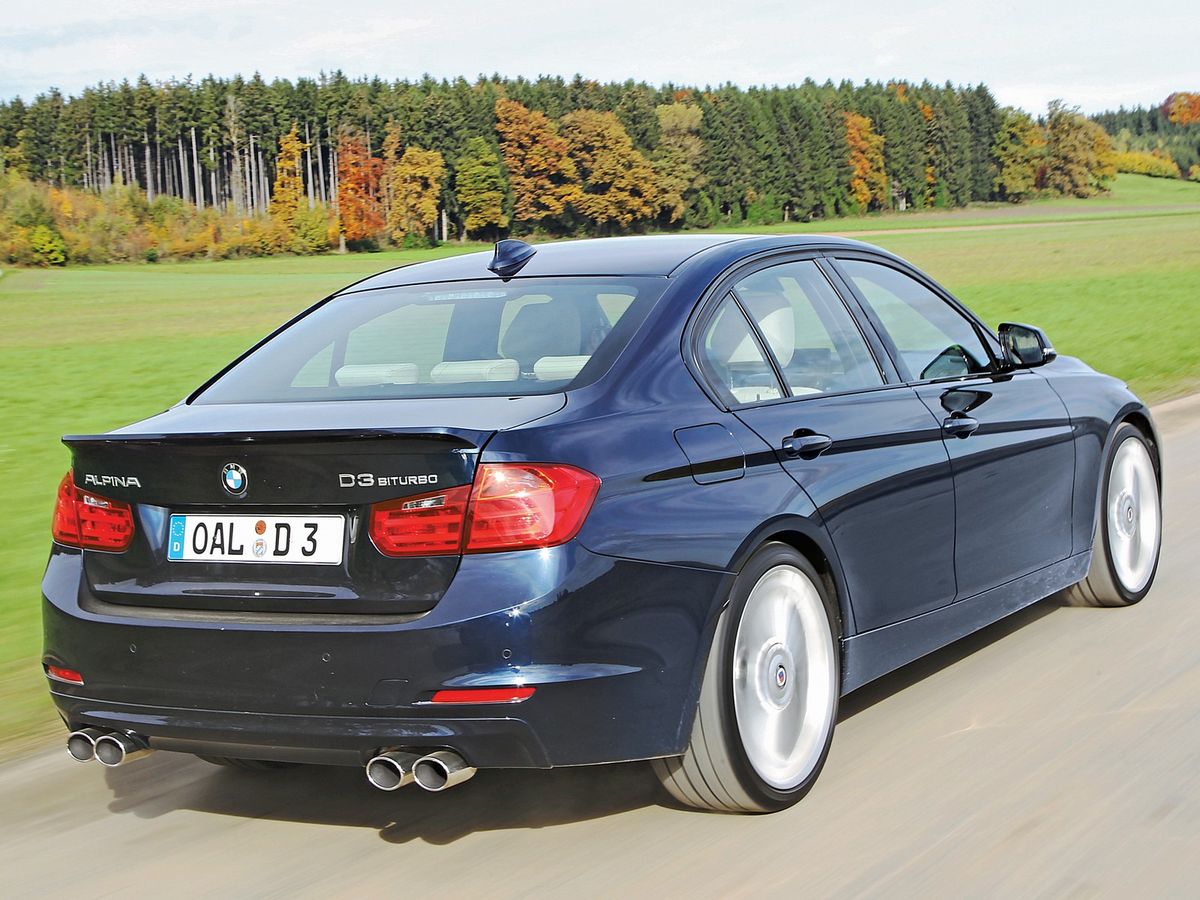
[104,598,1062,845]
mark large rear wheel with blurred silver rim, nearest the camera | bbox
[653,544,841,812]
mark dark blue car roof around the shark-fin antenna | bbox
[338,234,883,290]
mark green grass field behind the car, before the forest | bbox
[0,175,1200,757]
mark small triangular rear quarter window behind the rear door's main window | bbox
[700,296,784,404]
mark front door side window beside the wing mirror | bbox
[838,259,991,380]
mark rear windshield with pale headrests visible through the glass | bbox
[192,278,667,403]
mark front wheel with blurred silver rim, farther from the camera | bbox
[1066,422,1163,606]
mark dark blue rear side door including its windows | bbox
[696,258,955,631]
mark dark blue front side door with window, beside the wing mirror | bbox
[835,257,1075,599]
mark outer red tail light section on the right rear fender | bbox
[466,463,600,553]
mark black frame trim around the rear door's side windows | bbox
[680,247,905,412]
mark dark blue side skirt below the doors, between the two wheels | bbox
[841,550,1092,695]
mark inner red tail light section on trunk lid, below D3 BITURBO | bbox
[370,485,470,557]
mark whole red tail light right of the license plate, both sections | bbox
[370,463,600,557]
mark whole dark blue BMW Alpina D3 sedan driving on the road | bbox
[42,235,1162,811]
